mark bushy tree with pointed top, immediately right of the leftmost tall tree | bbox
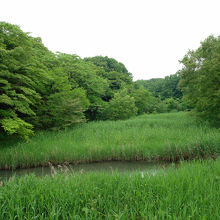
[35,67,89,129]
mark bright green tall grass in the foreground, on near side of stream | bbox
[0,159,220,220]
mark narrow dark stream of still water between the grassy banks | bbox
[0,161,168,179]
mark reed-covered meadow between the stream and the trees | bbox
[0,113,220,169]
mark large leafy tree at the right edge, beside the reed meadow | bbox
[180,36,220,126]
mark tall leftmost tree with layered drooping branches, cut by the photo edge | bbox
[0,22,44,138]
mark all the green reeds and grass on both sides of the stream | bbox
[0,113,220,219]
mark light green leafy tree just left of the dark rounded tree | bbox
[54,53,109,120]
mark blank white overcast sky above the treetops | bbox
[0,0,220,80]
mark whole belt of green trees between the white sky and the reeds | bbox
[0,22,220,138]
